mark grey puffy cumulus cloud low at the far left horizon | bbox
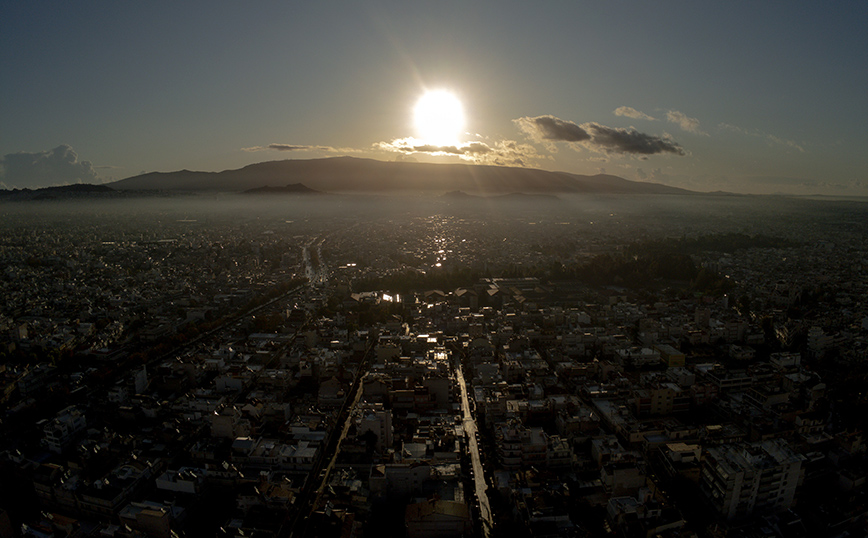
[0,144,99,188]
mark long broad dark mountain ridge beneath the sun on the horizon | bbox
[108,157,691,195]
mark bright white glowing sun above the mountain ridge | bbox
[413,90,464,146]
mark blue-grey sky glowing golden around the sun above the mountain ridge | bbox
[0,0,868,196]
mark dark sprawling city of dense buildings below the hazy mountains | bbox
[0,191,868,538]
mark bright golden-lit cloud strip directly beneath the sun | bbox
[374,137,541,166]
